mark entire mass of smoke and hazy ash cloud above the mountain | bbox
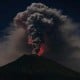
[0,3,80,70]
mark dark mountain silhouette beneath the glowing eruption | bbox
[0,55,80,80]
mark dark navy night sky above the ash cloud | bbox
[0,0,80,36]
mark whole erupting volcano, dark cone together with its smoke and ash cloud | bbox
[0,3,80,80]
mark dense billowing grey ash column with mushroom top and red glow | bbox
[13,3,66,55]
